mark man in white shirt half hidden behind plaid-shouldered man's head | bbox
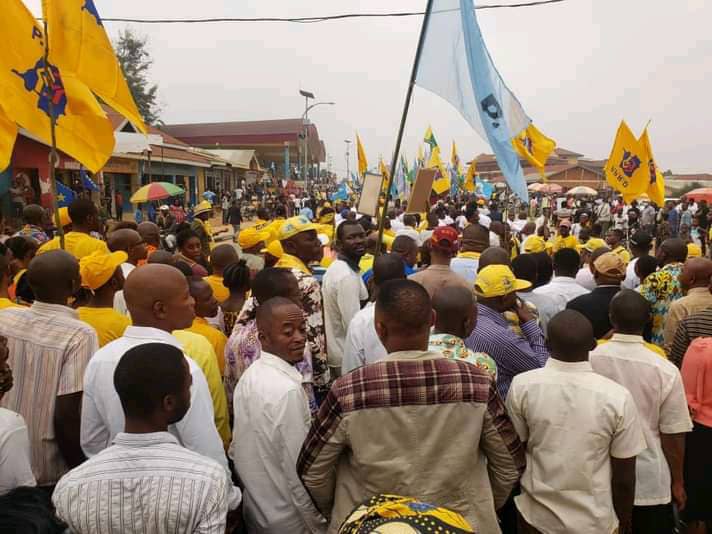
[341,254,405,374]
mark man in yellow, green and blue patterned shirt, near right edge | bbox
[639,238,687,347]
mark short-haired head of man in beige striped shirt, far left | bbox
[27,250,81,305]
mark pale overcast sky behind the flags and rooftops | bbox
[26,0,712,172]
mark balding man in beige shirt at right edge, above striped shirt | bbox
[663,258,712,354]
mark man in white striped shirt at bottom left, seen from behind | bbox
[52,343,232,534]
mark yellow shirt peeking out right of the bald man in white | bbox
[173,330,232,448]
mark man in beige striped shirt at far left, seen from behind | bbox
[0,250,99,487]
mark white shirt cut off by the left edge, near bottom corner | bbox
[0,408,37,495]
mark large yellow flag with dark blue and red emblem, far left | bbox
[0,0,114,172]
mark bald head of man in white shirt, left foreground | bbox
[124,264,195,332]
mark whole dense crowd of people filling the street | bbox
[0,189,712,534]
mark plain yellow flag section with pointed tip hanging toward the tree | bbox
[42,0,148,133]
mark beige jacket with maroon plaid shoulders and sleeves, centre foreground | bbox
[297,351,524,532]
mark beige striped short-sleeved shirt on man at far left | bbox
[0,301,99,486]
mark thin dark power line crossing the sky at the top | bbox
[92,0,567,24]
